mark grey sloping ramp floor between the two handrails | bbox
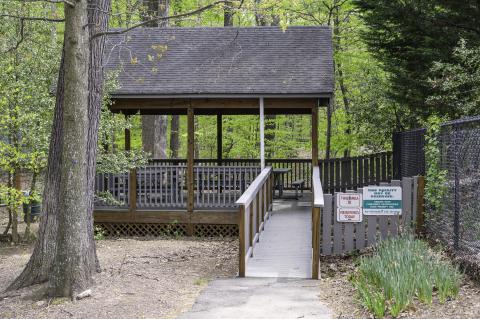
[246,198,312,278]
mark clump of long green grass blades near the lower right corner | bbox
[352,236,462,318]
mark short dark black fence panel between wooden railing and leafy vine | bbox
[393,128,427,179]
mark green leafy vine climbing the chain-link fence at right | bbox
[425,116,448,217]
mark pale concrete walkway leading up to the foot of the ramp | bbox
[179,278,332,319]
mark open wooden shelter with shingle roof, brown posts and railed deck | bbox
[95,27,334,239]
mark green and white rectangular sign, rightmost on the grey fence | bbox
[363,186,402,215]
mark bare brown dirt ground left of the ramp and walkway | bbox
[0,238,238,319]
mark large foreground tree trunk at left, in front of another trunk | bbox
[49,0,96,297]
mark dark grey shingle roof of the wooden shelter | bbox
[106,27,334,95]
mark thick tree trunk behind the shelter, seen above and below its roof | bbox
[142,0,169,158]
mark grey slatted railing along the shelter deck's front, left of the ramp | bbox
[95,163,260,213]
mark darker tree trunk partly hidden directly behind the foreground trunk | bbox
[8,0,111,290]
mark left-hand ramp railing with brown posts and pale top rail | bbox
[237,167,273,277]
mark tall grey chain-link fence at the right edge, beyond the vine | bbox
[426,116,480,270]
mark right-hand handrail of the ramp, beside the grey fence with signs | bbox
[312,166,324,279]
